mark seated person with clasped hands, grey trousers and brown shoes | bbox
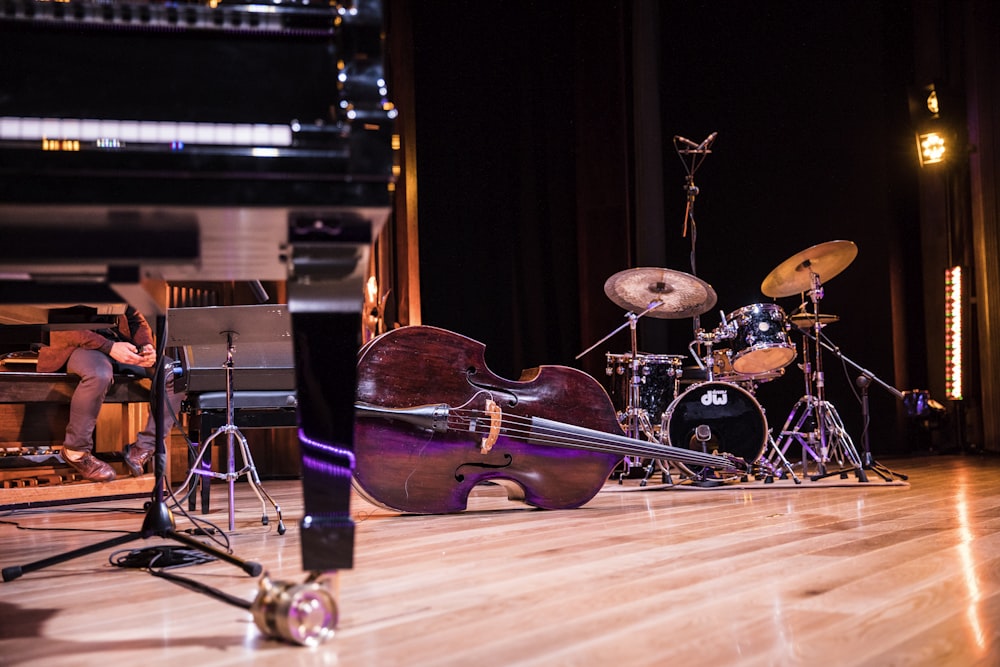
[38,306,184,482]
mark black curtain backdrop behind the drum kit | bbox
[394,0,927,454]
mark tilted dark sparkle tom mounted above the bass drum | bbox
[728,303,795,376]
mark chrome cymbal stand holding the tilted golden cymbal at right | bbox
[775,274,868,482]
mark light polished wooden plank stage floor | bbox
[0,456,1000,667]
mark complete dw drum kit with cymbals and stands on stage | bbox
[577,241,864,486]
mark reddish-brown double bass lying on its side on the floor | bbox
[353,325,737,514]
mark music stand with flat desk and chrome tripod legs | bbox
[167,304,292,535]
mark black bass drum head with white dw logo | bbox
[665,382,767,463]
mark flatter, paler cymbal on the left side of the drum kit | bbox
[604,267,718,319]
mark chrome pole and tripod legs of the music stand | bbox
[181,331,285,535]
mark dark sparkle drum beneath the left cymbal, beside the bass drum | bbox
[605,352,684,423]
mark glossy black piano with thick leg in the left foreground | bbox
[0,0,396,628]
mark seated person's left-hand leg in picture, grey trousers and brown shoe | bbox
[62,348,115,482]
